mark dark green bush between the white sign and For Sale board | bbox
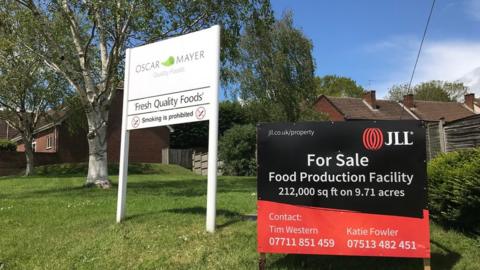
[219,125,257,175]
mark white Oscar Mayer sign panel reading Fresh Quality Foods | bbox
[127,25,220,130]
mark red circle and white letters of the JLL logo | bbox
[362,128,413,151]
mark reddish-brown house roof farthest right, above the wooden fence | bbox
[409,100,475,122]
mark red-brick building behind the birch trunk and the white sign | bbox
[12,89,173,163]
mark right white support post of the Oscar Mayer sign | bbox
[206,25,220,233]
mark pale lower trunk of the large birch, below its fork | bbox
[86,107,111,188]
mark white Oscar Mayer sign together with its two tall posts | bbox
[117,25,220,232]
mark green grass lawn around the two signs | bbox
[0,165,480,270]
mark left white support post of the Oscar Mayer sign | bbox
[117,49,130,223]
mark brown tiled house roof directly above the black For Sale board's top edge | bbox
[323,96,414,120]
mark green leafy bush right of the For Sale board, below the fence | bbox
[428,148,480,230]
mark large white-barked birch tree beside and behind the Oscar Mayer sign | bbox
[2,0,270,187]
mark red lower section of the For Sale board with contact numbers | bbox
[257,201,430,258]
